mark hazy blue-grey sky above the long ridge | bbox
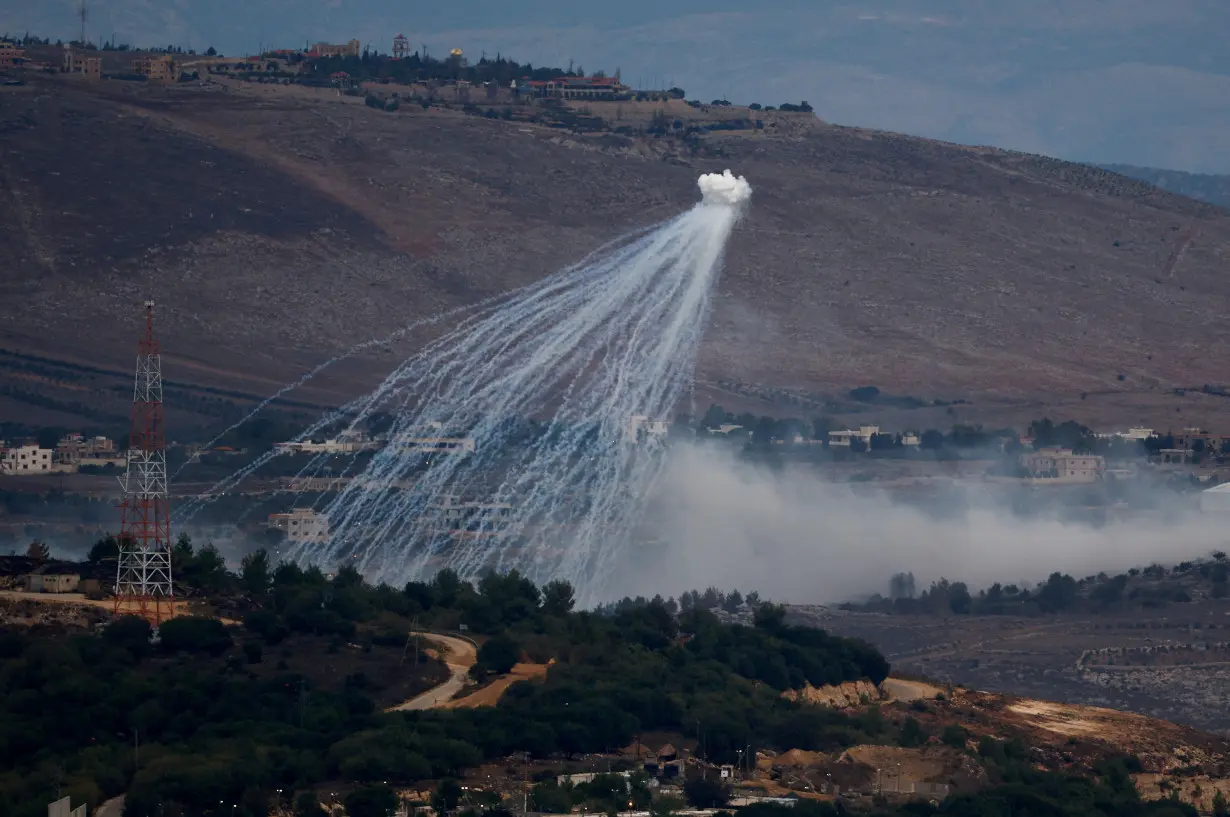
[9,0,1230,173]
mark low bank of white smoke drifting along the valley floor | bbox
[613,445,1226,604]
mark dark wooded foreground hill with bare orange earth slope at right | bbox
[0,561,1230,817]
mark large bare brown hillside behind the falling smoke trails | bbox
[0,78,1230,426]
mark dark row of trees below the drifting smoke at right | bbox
[843,551,1230,615]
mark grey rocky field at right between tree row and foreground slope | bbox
[801,602,1230,735]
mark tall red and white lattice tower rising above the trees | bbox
[116,300,175,626]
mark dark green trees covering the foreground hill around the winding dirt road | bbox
[0,539,888,817]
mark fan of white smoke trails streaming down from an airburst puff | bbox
[271,171,752,603]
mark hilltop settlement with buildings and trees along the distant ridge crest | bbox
[0,34,817,137]
